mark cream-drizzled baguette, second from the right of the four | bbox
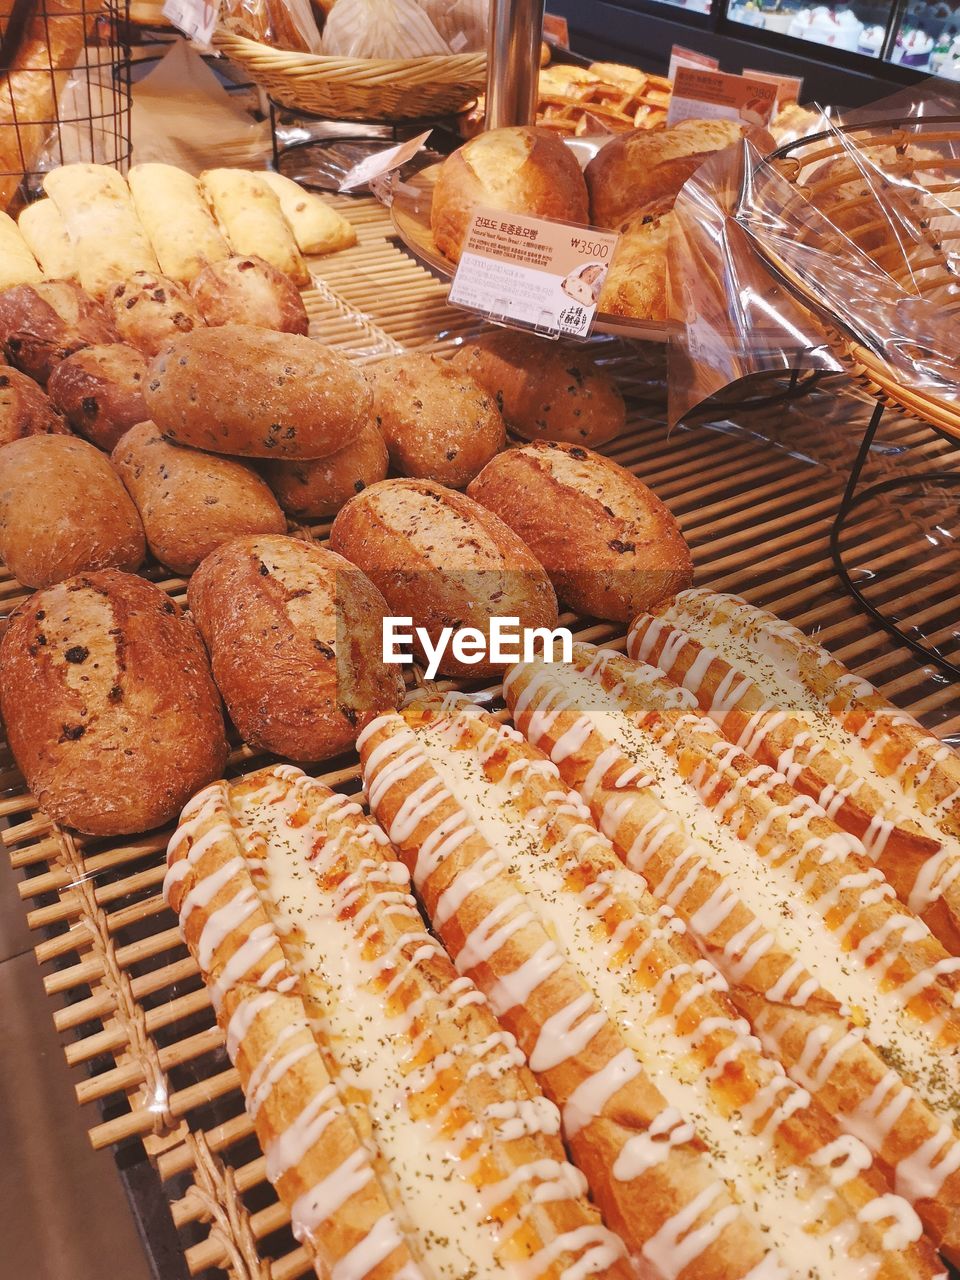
[504,645,960,1256]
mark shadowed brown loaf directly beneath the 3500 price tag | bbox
[452,329,626,444]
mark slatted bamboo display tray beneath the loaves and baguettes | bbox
[0,192,960,1280]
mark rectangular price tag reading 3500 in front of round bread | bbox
[449,209,620,338]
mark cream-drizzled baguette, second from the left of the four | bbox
[361,695,936,1280]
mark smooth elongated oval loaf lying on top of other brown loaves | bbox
[146,325,372,458]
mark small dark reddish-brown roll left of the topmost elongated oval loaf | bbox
[47,342,148,451]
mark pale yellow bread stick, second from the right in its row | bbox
[200,169,310,285]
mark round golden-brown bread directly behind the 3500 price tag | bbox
[430,125,589,262]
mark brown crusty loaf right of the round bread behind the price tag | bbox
[584,120,744,228]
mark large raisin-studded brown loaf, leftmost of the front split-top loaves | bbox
[0,573,227,836]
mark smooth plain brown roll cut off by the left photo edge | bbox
[0,435,145,586]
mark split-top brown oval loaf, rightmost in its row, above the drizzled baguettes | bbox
[467,443,692,622]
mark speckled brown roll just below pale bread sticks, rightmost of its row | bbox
[189,257,310,334]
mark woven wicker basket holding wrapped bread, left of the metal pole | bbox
[214,31,486,120]
